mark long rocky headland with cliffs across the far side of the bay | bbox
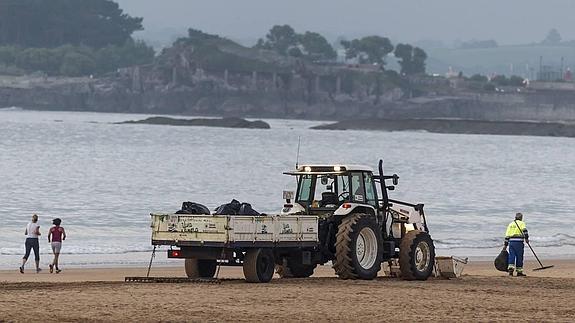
[0,29,575,135]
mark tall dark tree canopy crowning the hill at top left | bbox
[0,0,143,48]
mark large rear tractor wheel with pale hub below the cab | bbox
[333,214,383,279]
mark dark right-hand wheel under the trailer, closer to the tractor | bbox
[244,248,275,283]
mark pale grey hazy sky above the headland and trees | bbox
[116,0,575,45]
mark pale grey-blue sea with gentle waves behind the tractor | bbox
[0,108,575,269]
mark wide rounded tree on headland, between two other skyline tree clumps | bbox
[341,36,393,66]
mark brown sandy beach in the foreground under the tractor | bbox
[0,260,575,322]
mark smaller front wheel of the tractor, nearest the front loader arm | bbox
[399,230,435,280]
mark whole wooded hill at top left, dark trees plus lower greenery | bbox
[0,0,154,76]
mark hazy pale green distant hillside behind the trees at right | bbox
[426,45,575,78]
